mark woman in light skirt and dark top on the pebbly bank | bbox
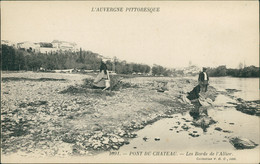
[93,59,110,90]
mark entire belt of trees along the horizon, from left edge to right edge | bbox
[1,45,260,77]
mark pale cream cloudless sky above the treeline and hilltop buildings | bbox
[1,1,259,68]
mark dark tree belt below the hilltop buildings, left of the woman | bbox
[2,45,100,71]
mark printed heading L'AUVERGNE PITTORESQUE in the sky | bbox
[91,7,160,13]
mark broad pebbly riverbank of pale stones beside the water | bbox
[1,72,223,157]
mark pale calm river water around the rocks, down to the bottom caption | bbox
[92,77,259,163]
